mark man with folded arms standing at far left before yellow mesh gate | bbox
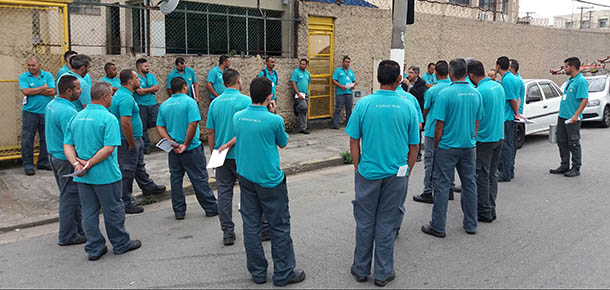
[19,56,56,175]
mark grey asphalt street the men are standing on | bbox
[0,128,610,288]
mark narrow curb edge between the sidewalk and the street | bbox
[0,157,345,234]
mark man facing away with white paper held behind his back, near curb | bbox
[157,77,218,220]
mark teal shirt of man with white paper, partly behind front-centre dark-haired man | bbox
[206,89,252,159]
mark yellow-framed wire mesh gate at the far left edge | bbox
[0,0,68,160]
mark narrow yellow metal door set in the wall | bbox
[308,16,335,119]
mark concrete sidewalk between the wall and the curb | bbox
[0,128,349,233]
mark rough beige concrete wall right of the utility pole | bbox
[405,14,610,85]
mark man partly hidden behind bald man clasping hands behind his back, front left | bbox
[45,76,87,246]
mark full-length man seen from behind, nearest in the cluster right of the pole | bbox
[421,59,484,238]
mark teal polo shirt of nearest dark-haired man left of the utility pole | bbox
[233,105,288,188]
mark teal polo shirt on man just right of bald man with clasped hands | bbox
[108,86,143,140]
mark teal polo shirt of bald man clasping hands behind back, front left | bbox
[64,104,122,184]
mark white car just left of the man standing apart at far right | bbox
[516,79,562,148]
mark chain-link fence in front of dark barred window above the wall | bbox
[70,0,297,56]
